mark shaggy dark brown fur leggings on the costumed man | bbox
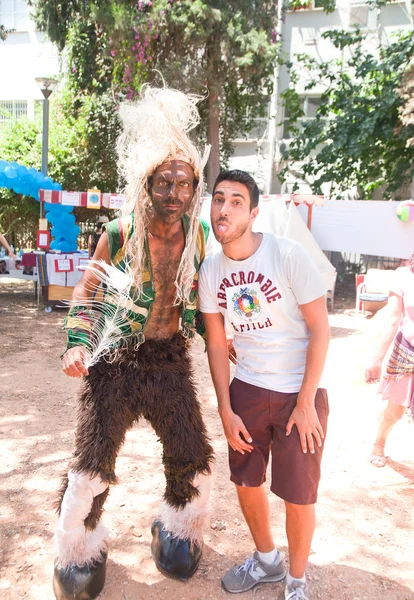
[58,334,213,530]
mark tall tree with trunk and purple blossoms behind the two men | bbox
[30,0,278,189]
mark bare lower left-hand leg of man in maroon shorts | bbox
[236,485,275,552]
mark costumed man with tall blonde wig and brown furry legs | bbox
[53,87,213,600]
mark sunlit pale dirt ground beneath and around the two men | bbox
[0,279,414,600]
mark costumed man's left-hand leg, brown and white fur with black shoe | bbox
[54,363,133,600]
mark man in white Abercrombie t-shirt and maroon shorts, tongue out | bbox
[199,170,329,600]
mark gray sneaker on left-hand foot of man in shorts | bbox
[221,552,286,594]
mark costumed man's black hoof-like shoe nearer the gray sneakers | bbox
[151,521,203,581]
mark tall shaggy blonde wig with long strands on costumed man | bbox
[118,86,210,304]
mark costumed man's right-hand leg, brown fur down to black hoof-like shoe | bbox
[143,336,213,580]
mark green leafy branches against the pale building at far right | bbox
[280,30,414,198]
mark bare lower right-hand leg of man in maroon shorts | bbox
[285,501,315,579]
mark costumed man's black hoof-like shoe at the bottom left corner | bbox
[53,553,108,600]
